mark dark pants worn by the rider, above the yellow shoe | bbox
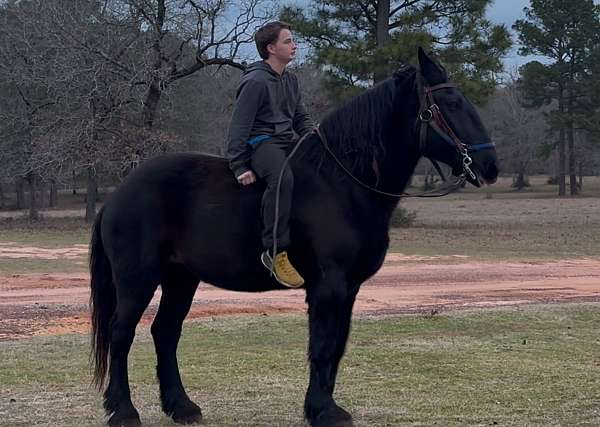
[252,140,294,252]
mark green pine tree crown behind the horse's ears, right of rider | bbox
[281,0,511,102]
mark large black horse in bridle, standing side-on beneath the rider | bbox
[90,50,498,426]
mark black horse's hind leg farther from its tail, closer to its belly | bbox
[151,265,202,424]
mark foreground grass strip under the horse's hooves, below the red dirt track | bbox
[0,304,600,427]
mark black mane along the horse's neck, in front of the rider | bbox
[304,67,416,173]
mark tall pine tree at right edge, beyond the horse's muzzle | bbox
[513,0,600,196]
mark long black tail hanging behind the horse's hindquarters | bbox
[90,209,116,389]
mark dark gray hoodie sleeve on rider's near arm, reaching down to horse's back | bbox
[227,79,265,177]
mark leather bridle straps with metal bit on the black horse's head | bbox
[416,77,496,179]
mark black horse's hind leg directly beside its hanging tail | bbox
[104,272,159,426]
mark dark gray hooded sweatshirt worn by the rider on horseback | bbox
[227,61,314,177]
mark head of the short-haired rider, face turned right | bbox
[254,21,296,64]
